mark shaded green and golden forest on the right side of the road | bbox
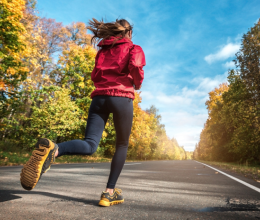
[193,20,260,164]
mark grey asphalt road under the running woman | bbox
[0,160,260,220]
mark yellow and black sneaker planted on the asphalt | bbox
[98,188,124,206]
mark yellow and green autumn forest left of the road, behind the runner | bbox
[0,0,189,160]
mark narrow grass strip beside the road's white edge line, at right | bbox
[198,160,260,182]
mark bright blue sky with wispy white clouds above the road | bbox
[38,0,260,151]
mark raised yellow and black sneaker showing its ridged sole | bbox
[20,138,58,190]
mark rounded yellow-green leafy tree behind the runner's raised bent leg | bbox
[1,86,86,149]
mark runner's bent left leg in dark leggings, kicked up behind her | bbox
[57,96,109,157]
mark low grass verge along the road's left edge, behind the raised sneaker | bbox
[0,151,111,166]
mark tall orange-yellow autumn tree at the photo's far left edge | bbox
[0,0,39,134]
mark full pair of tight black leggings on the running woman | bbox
[58,96,133,189]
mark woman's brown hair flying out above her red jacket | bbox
[87,18,133,46]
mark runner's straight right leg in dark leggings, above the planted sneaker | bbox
[107,97,133,190]
